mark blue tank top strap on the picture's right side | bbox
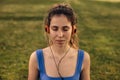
[76,50,84,74]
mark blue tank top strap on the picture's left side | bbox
[36,49,45,73]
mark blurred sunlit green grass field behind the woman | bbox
[0,0,120,80]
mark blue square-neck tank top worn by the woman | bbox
[36,49,84,80]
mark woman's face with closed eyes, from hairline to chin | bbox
[49,15,72,46]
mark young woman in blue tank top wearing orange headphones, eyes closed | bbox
[28,4,90,80]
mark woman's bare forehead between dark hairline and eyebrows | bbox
[50,14,71,26]
